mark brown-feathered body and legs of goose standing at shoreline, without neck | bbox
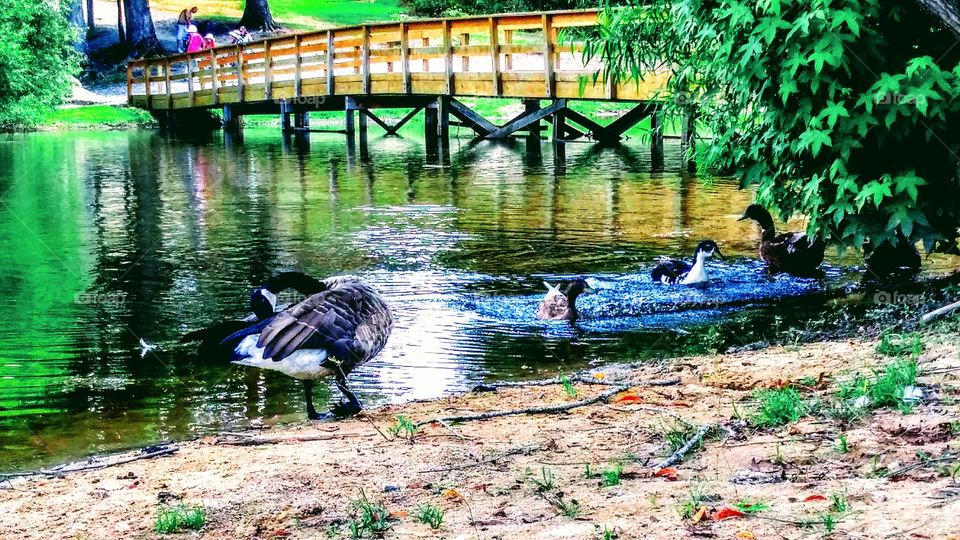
[221,275,393,420]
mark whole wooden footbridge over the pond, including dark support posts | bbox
[127,10,693,156]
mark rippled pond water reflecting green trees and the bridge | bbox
[0,130,896,470]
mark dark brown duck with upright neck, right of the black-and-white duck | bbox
[737,204,827,275]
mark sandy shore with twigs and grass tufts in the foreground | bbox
[0,335,960,539]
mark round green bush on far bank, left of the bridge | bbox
[0,0,79,130]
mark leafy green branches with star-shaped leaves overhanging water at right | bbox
[586,0,960,251]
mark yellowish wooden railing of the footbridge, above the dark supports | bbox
[127,10,662,109]
